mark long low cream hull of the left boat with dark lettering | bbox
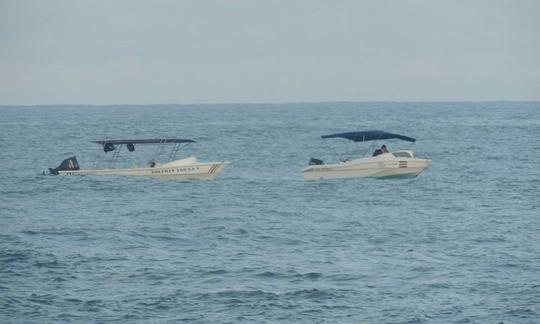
[58,162,229,180]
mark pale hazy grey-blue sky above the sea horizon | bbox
[0,0,540,105]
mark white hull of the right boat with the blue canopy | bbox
[302,153,431,180]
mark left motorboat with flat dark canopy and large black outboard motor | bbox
[49,139,229,180]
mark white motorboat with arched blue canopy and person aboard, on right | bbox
[302,130,431,180]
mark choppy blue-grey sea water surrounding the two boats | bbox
[0,103,540,323]
